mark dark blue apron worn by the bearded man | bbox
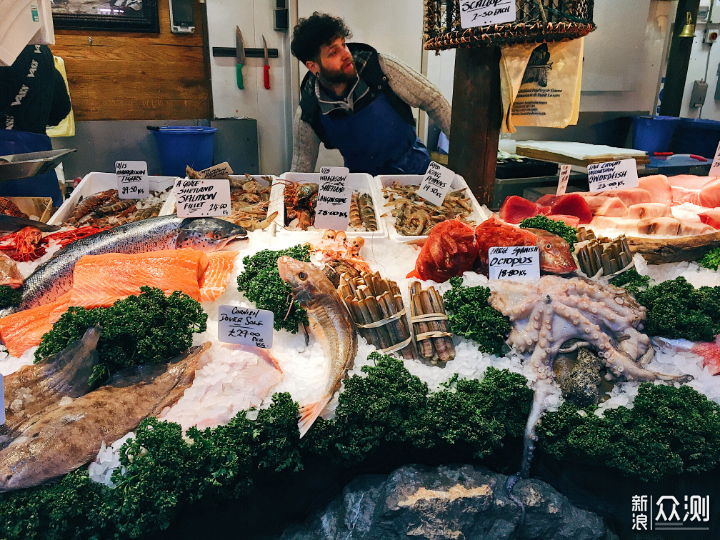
[320,94,430,176]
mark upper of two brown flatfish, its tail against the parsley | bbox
[0,325,101,448]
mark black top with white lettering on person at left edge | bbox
[0,45,70,133]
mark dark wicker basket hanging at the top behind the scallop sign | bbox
[425,0,595,50]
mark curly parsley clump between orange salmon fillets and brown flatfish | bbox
[35,287,207,385]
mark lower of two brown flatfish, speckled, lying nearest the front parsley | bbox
[0,343,210,492]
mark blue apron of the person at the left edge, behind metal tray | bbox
[0,129,63,207]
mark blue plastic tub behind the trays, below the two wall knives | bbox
[153,126,217,178]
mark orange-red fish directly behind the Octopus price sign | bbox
[475,217,577,275]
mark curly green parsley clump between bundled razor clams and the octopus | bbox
[443,277,512,356]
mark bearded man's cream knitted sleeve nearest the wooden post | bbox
[379,53,452,138]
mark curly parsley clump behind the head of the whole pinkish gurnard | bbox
[238,245,310,334]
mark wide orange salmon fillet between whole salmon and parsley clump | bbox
[70,249,208,308]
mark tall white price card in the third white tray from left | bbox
[315,167,352,231]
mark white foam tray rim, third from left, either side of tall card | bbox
[270,172,387,238]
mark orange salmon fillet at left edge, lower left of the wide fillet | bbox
[0,292,71,357]
